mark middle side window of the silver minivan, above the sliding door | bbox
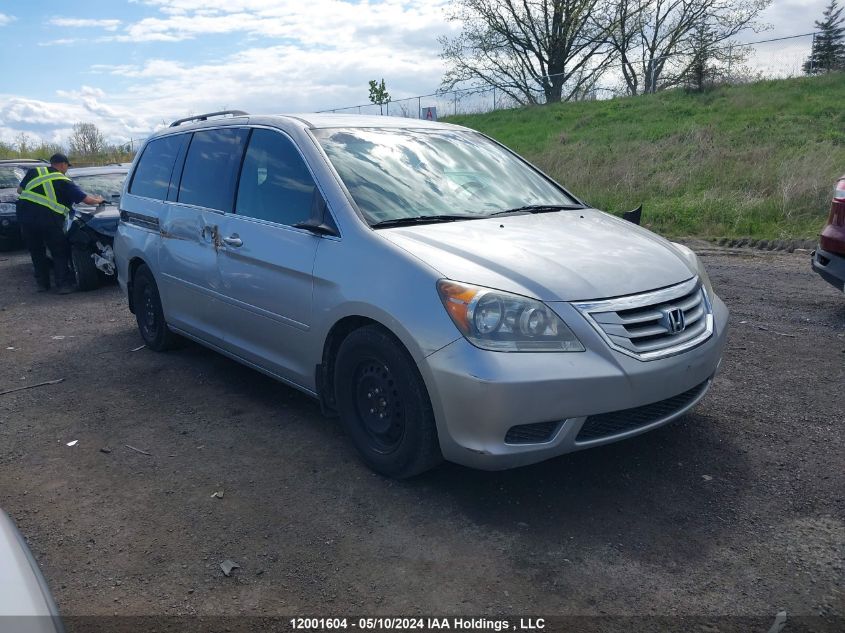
[179,128,249,211]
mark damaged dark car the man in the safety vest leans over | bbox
[66,164,129,290]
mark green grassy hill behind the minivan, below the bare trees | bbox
[448,73,845,239]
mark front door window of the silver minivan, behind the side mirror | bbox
[235,129,316,226]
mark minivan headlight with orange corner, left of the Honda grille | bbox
[437,279,584,352]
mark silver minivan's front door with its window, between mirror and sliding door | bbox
[217,128,321,386]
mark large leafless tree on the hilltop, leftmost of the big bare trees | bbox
[440,0,616,105]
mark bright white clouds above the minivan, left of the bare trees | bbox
[0,0,462,142]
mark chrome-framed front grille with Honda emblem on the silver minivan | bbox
[575,279,713,360]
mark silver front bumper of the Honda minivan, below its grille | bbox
[421,297,728,470]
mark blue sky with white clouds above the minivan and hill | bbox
[0,0,829,144]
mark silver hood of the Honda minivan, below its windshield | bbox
[378,209,696,301]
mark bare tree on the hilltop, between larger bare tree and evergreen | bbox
[611,0,771,95]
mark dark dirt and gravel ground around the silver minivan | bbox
[0,243,845,633]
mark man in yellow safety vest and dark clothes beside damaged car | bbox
[17,154,103,294]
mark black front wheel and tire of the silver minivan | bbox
[334,326,443,479]
